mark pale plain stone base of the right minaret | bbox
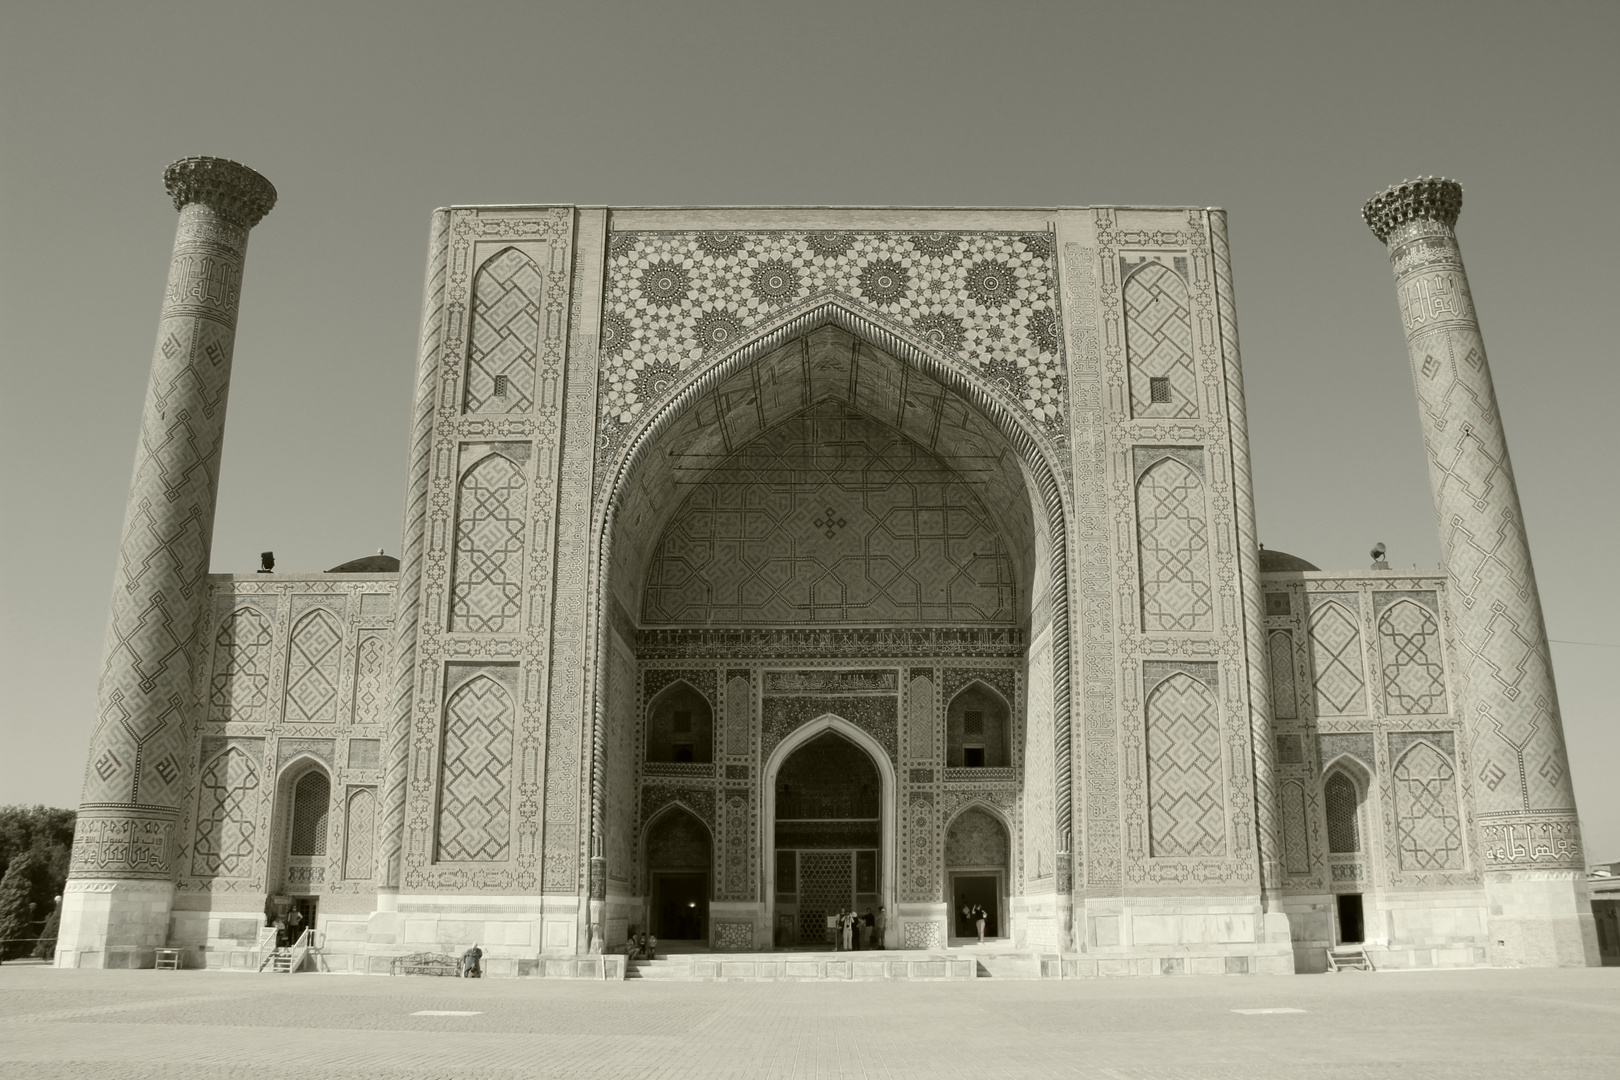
[1486,870,1602,968]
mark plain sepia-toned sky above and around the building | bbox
[0,0,1620,861]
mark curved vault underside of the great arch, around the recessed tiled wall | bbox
[612,327,1038,622]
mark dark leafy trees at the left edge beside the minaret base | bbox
[0,806,76,960]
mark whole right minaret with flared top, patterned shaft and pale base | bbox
[1361,178,1599,967]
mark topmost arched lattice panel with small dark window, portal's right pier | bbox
[1124,262,1199,418]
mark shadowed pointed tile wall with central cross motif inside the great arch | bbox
[643,400,1016,627]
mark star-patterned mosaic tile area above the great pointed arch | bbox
[599,232,1066,453]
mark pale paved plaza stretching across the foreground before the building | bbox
[0,965,1620,1080]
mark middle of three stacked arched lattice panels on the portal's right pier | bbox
[1136,458,1215,630]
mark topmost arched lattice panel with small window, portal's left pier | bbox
[467,248,543,413]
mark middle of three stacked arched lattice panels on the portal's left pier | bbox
[450,453,528,633]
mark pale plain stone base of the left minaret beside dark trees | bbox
[55,878,175,968]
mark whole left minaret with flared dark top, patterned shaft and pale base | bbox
[57,157,275,967]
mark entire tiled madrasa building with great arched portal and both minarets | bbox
[57,159,1597,978]
